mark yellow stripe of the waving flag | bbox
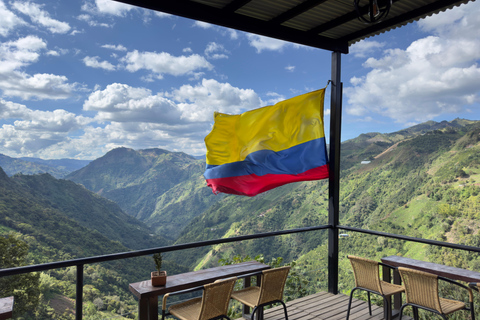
[205,89,325,165]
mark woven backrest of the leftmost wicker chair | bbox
[198,278,237,320]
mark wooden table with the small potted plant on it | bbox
[129,261,270,320]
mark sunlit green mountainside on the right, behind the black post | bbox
[170,120,480,285]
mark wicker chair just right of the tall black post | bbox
[347,255,405,320]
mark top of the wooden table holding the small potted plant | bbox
[129,261,271,299]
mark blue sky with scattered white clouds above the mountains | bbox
[0,0,480,159]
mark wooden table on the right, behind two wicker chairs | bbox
[382,256,480,312]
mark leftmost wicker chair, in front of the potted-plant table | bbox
[162,278,237,320]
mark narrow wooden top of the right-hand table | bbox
[382,256,480,282]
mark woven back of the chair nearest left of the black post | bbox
[257,266,290,306]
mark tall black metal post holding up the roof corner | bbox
[328,52,342,294]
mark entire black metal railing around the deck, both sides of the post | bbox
[0,225,480,320]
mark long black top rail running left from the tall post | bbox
[0,225,330,277]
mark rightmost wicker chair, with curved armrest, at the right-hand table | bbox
[398,267,475,320]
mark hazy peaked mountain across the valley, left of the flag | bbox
[67,148,221,238]
